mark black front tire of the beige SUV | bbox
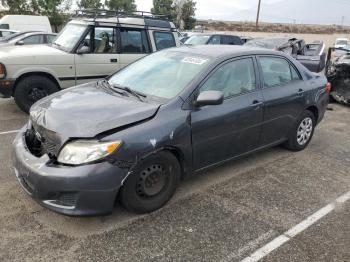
[13,75,59,113]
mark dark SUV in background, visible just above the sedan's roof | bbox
[184,34,243,45]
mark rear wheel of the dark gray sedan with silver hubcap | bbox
[284,110,316,151]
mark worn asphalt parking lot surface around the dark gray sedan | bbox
[0,99,350,262]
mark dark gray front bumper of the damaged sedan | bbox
[13,132,127,216]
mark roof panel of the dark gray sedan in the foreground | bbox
[170,45,285,57]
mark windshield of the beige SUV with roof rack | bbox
[52,24,87,52]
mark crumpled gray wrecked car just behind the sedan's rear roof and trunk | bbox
[244,37,326,73]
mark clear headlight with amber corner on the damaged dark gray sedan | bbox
[57,140,122,165]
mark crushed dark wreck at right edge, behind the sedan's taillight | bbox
[326,47,350,105]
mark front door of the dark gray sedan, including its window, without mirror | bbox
[191,57,263,169]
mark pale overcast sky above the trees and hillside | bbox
[135,0,350,25]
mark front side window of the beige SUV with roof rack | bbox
[81,27,117,54]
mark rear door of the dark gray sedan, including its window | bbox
[258,56,306,146]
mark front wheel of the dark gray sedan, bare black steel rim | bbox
[119,151,181,213]
